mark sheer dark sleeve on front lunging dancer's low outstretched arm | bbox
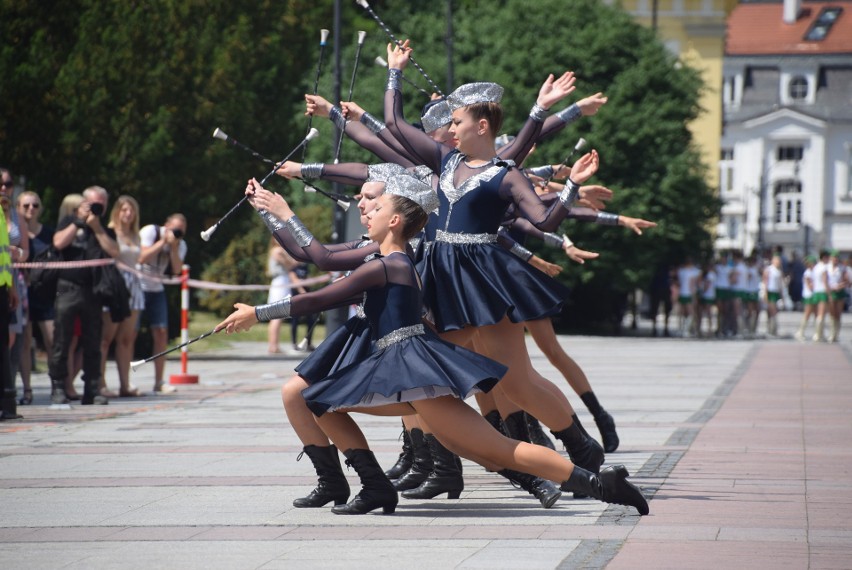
[290,259,387,317]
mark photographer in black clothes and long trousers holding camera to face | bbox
[48,186,118,405]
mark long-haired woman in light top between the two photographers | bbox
[101,196,145,398]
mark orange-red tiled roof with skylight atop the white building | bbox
[725,0,852,56]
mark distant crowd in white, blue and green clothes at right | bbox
[649,247,852,342]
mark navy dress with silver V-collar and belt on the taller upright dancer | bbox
[419,151,568,332]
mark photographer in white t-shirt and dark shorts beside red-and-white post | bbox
[139,214,186,394]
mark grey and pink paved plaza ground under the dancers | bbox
[0,314,852,570]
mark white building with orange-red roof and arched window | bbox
[716,0,852,254]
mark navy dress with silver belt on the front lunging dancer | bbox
[292,253,506,415]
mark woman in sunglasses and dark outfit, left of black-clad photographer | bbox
[17,190,55,406]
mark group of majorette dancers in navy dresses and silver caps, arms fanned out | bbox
[217,42,654,514]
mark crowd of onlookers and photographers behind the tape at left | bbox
[0,164,186,419]
